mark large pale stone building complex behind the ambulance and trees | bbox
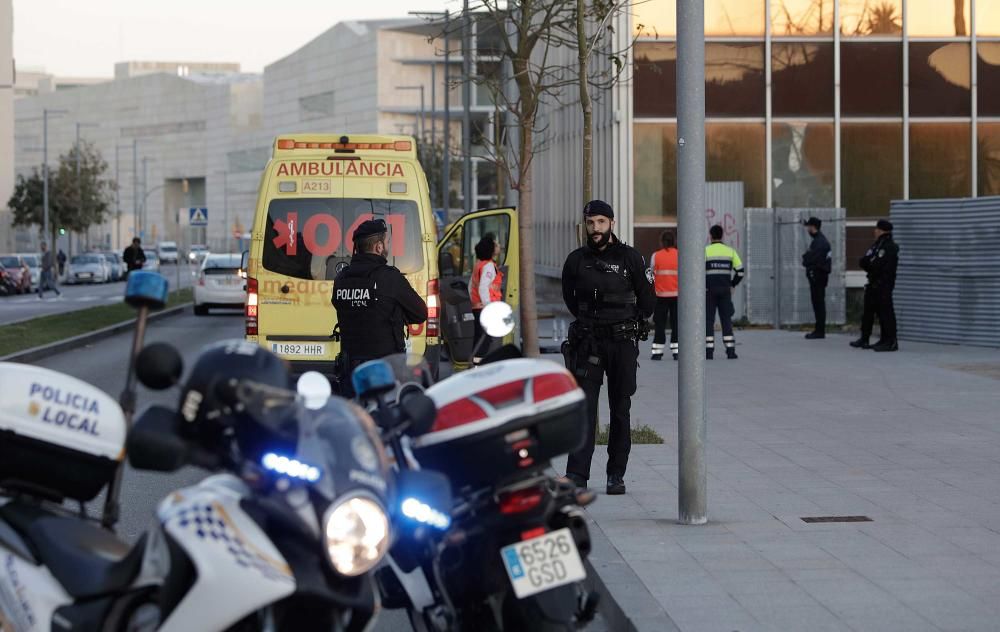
[8,15,494,251]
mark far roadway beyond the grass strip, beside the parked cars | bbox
[0,263,195,325]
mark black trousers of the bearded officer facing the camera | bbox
[566,339,639,479]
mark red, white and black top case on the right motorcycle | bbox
[414,358,587,489]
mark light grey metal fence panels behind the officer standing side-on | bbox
[745,208,847,325]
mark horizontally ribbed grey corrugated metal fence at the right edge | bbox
[890,197,1000,347]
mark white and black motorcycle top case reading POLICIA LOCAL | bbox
[0,362,127,501]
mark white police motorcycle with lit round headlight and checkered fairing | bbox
[0,273,391,632]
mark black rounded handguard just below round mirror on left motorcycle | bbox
[125,406,188,472]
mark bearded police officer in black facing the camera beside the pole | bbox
[562,200,656,494]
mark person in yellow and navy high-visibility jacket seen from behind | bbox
[705,224,743,360]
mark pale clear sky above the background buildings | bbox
[14,0,461,77]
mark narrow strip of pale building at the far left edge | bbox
[0,0,14,251]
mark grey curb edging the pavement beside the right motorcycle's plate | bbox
[584,518,680,632]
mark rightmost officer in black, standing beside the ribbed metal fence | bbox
[851,219,899,351]
